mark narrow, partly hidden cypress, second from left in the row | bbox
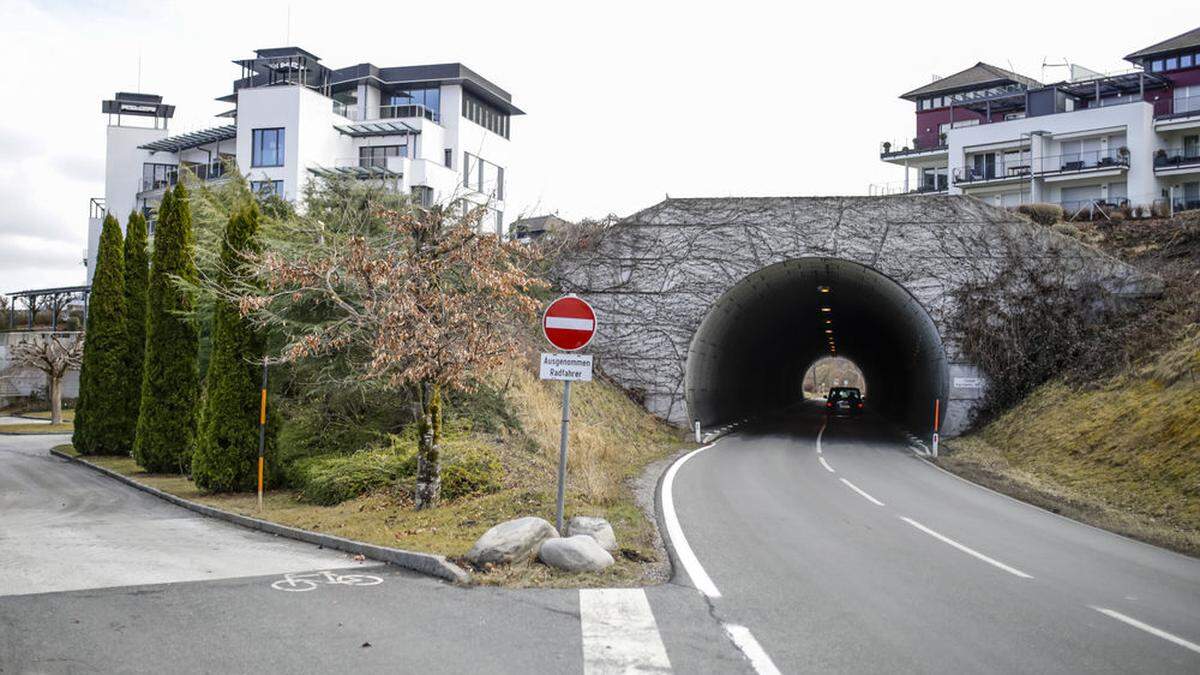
[125,211,150,448]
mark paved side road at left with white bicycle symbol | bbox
[0,427,750,675]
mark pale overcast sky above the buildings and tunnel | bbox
[0,0,1200,292]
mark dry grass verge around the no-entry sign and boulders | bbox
[60,368,684,587]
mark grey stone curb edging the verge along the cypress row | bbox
[50,448,470,584]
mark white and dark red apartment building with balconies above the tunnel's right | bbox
[880,28,1200,213]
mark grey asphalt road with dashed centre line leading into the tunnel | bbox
[664,407,1200,673]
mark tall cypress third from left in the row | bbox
[133,183,200,473]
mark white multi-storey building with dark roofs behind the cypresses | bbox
[88,47,523,283]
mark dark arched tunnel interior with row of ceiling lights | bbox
[685,258,948,429]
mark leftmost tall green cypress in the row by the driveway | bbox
[71,214,132,455]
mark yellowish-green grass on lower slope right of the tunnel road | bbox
[943,327,1200,555]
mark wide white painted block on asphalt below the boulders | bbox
[580,589,671,675]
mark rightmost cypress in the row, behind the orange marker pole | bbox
[192,204,276,492]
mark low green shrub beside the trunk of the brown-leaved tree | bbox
[288,449,416,506]
